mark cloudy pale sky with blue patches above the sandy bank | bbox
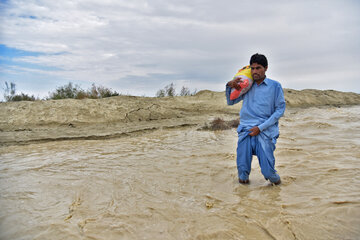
[0,0,360,99]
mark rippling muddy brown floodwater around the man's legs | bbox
[0,106,360,239]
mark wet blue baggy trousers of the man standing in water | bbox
[236,131,280,183]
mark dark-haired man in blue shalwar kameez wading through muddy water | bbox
[226,53,285,185]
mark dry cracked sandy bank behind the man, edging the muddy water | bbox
[0,89,360,145]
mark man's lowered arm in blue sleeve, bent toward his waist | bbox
[258,83,286,131]
